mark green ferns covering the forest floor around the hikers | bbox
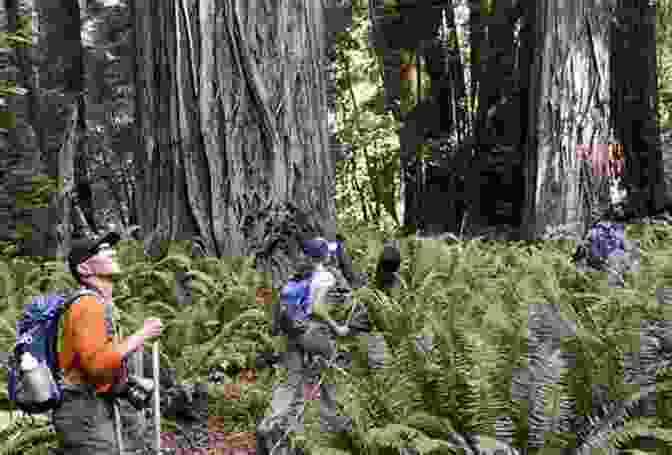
[0,225,672,455]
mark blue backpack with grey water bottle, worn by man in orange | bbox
[8,288,96,414]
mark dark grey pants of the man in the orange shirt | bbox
[52,385,119,455]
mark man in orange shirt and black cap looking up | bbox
[52,232,163,455]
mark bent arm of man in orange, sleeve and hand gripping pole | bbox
[72,296,142,383]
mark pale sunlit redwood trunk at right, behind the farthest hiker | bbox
[523,0,611,238]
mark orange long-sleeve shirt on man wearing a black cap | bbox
[58,295,122,393]
